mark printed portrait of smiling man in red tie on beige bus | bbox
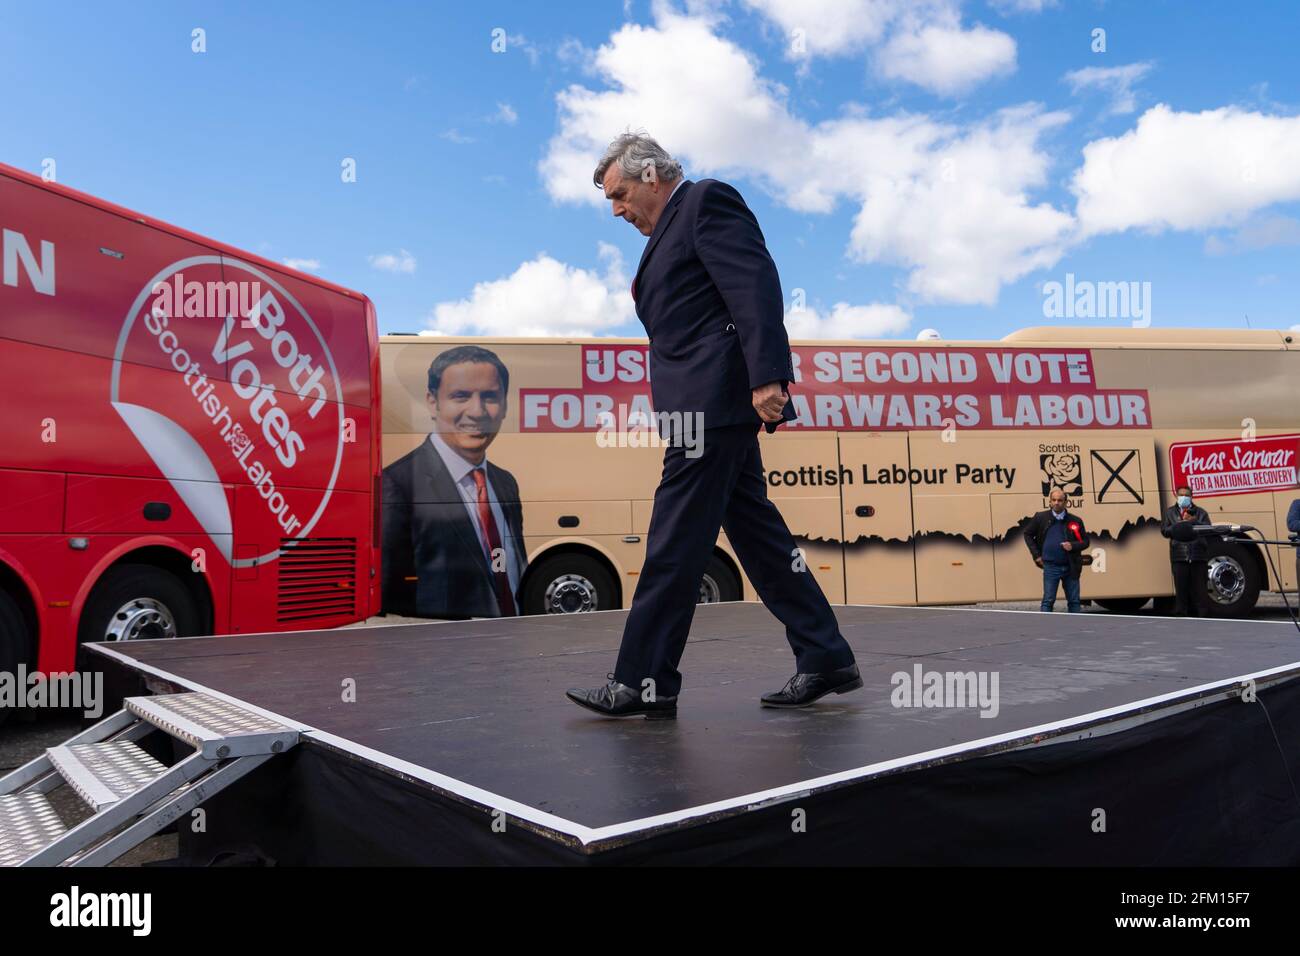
[382,345,527,618]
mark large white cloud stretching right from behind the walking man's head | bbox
[538,14,1071,303]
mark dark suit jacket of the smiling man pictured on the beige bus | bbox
[381,438,524,618]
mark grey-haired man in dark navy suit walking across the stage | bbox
[568,133,862,718]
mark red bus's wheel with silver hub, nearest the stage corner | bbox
[77,564,199,644]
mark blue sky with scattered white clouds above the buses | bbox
[0,0,1300,338]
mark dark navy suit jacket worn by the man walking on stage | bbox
[632,179,797,432]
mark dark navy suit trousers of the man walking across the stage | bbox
[614,424,854,697]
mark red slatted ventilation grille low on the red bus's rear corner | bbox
[276,537,356,622]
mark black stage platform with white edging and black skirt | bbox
[86,604,1300,865]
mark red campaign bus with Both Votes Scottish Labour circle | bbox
[0,165,381,674]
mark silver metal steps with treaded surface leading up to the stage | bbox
[0,693,299,866]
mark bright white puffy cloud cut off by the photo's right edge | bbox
[1071,104,1300,235]
